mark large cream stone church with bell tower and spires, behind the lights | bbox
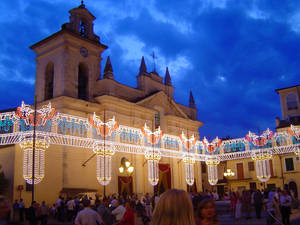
[0,3,203,205]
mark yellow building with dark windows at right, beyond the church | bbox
[220,85,300,196]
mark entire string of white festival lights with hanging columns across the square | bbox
[0,102,300,190]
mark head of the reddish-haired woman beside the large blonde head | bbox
[197,198,217,222]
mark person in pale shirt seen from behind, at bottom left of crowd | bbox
[75,199,103,225]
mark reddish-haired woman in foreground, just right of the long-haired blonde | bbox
[196,199,219,225]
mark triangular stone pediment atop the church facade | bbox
[136,91,188,119]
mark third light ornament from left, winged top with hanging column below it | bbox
[142,123,162,186]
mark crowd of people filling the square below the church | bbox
[0,189,294,225]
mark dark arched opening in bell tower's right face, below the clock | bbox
[78,63,88,100]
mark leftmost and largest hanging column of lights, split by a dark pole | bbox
[20,134,49,184]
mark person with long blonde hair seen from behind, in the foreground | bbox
[151,189,195,225]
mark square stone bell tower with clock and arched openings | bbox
[30,1,107,102]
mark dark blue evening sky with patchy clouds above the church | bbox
[0,0,300,138]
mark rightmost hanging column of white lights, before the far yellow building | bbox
[251,149,272,182]
